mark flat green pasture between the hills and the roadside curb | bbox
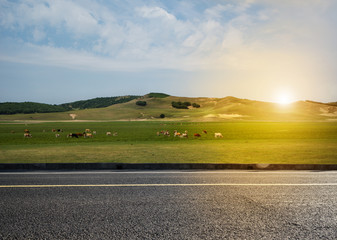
[0,121,337,164]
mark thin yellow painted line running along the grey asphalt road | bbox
[0,183,337,188]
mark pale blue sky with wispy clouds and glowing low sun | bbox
[0,0,337,104]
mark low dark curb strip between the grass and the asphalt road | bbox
[0,163,337,171]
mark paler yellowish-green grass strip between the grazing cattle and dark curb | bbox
[0,139,337,164]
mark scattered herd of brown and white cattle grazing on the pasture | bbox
[21,128,223,138]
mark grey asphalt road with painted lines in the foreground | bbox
[0,171,337,239]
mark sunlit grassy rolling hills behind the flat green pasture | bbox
[0,93,337,121]
